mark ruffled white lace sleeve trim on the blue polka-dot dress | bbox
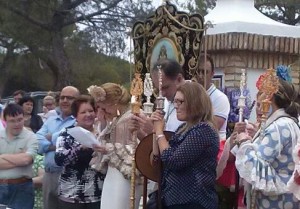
[235,144,288,195]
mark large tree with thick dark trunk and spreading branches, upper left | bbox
[0,0,151,90]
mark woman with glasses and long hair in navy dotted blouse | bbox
[151,82,219,209]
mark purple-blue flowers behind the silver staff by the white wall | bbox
[224,87,255,123]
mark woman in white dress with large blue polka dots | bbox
[232,79,300,209]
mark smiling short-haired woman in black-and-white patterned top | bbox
[55,95,104,209]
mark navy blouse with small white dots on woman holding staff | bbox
[161,123,219,209]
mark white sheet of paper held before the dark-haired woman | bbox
[68,126,100,148]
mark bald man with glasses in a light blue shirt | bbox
[36,86,79,209]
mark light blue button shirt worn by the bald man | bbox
[36,115,75,173]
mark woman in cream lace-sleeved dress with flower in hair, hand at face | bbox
[88,83,142,209]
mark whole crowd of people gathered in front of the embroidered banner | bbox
[0,55,300,209]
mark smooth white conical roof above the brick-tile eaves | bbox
[204,0,300,38]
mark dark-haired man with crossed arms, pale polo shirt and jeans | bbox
[0,104,38,209]
